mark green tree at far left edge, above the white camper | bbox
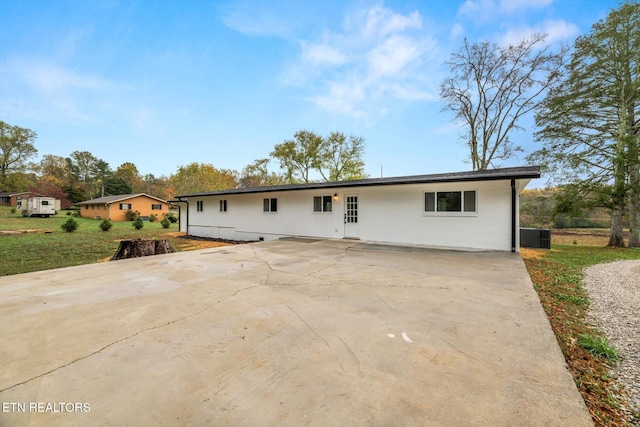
[0,121,38,190]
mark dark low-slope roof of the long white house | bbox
[176,166,540,198]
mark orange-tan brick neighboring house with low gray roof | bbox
[76,193,169,221]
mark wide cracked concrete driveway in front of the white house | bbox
[0,239,592,426]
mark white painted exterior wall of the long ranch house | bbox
[182,180,528,251]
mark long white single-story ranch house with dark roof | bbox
[172,166,540,252]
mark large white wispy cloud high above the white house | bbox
[283,5,442,122]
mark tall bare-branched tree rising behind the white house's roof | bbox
[440,34,567,170]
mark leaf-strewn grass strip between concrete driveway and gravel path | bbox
[522,245,640,427]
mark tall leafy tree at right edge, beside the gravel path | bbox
[529,2,640,247]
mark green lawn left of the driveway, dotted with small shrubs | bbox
[0,206,184,276]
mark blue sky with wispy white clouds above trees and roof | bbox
[0,0,618,182]
